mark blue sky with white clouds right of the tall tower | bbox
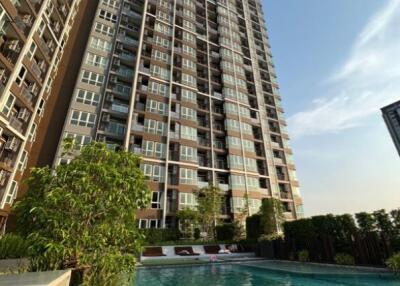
[262,0,400,216]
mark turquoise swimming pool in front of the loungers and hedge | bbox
[136,261,400,286]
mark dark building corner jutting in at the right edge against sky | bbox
[382,100,400,155]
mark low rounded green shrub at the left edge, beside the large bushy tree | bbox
[0,234,28,259]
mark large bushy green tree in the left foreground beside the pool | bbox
[14,141,150,285]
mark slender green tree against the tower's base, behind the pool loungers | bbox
[196,185,223,239]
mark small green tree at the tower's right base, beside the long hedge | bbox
[260,198,285,235]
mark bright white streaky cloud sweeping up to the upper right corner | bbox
[289,0,400,138]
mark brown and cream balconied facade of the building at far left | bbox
[0,0,80,232]
